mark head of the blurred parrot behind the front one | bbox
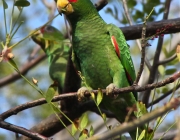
[31,25,64,53]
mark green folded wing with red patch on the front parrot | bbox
[107,24,137,99]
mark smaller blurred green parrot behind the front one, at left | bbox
[31,25,70,93]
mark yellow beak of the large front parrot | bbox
[57,0,74,15]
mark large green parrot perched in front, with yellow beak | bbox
[57,0,144,140]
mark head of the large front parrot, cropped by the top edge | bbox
[57,0,96,17]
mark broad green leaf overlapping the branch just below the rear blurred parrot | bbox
[45,84,57,103]
